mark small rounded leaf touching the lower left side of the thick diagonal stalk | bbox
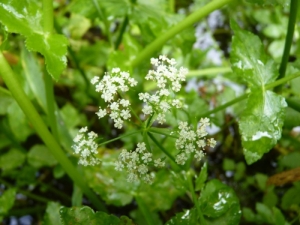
[27,145,57,168]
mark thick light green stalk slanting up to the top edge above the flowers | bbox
[131,0,234,67]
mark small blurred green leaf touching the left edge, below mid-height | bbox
[0,148,26,170]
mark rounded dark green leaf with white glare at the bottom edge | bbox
[199,180,241,225]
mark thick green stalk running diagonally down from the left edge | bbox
[0,52,106,211]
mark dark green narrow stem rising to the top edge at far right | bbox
[276,0,298,91]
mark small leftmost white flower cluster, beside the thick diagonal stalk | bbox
[72,127,101,166]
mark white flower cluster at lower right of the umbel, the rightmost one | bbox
[175,118,216,165]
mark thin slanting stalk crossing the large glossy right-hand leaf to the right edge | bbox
[198,73,300,118]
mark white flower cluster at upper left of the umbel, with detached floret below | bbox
[91,68,137,129]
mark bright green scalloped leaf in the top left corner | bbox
[0,0,68,80]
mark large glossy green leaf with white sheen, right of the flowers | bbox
[231,21,287,164]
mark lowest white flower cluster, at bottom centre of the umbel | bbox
[115,142,165,184]
